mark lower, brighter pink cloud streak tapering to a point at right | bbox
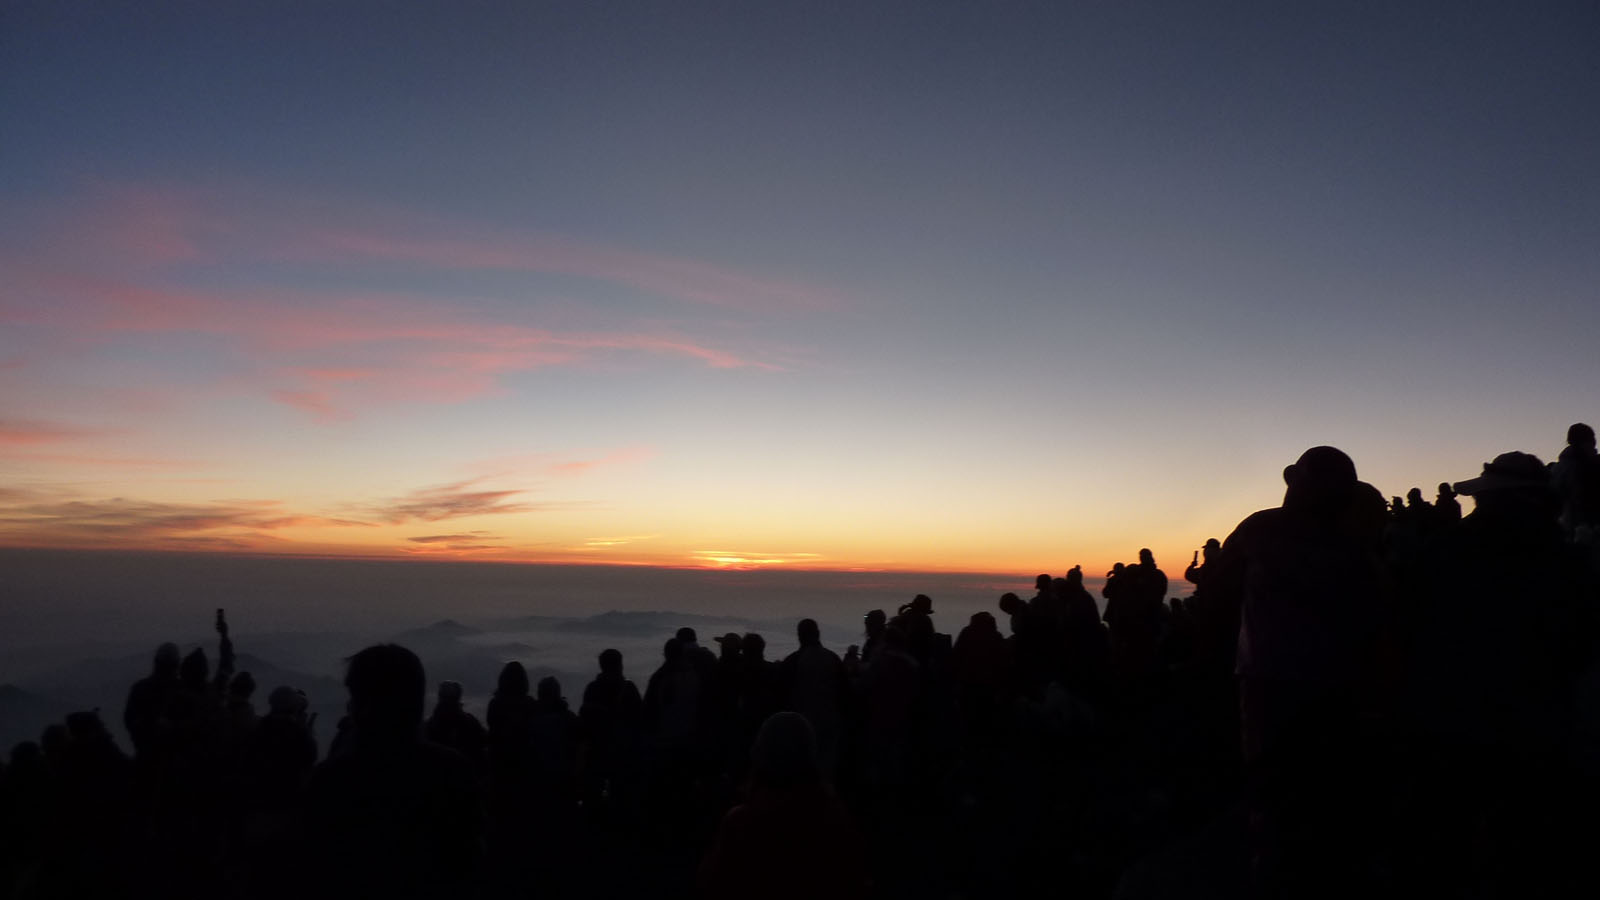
[0,269,779,423]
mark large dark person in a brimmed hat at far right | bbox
[1402,452,1597,897]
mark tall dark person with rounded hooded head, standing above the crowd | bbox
[1206,447,1386,895]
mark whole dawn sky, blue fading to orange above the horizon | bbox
[0,0,1600,572]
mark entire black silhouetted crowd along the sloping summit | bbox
[0,424,1600,900]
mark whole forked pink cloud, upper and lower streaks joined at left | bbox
[0,184,837,423]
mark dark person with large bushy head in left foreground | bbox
[301,644,483,900]
